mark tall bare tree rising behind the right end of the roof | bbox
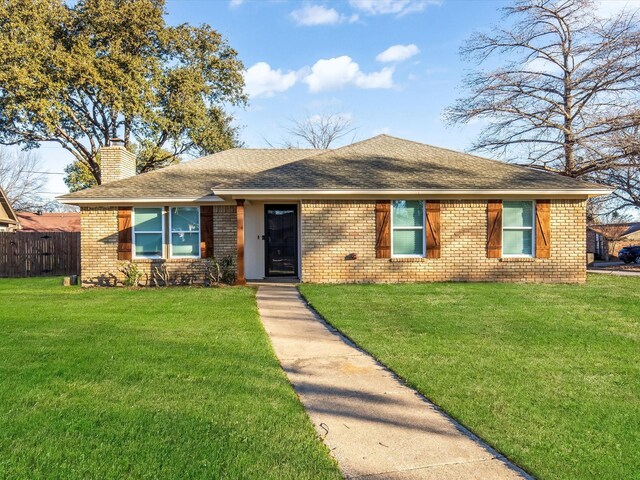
[446,0,640,177]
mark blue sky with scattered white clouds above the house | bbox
[40,0,640,196]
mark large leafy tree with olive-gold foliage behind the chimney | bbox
[0,0,247,187]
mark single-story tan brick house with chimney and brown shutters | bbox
[58,135,611,285]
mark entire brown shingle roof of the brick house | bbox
[59,135,605,201]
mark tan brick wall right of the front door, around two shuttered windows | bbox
[301,200,586,283]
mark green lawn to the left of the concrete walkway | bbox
[0,279,340,480]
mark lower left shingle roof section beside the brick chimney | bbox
[58,148,321,200]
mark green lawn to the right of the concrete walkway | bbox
[300,275,640,480]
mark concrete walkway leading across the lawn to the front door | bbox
[258,284,528,480]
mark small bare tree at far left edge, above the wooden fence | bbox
[0,148,46,210]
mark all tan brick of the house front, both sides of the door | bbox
[82,200,586,285]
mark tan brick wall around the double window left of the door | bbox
[81,205,236,286]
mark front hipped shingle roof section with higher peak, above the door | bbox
[214,135,603,192]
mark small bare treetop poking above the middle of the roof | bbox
[285,113,357,150]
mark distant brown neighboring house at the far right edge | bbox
[587,222,640,260]
